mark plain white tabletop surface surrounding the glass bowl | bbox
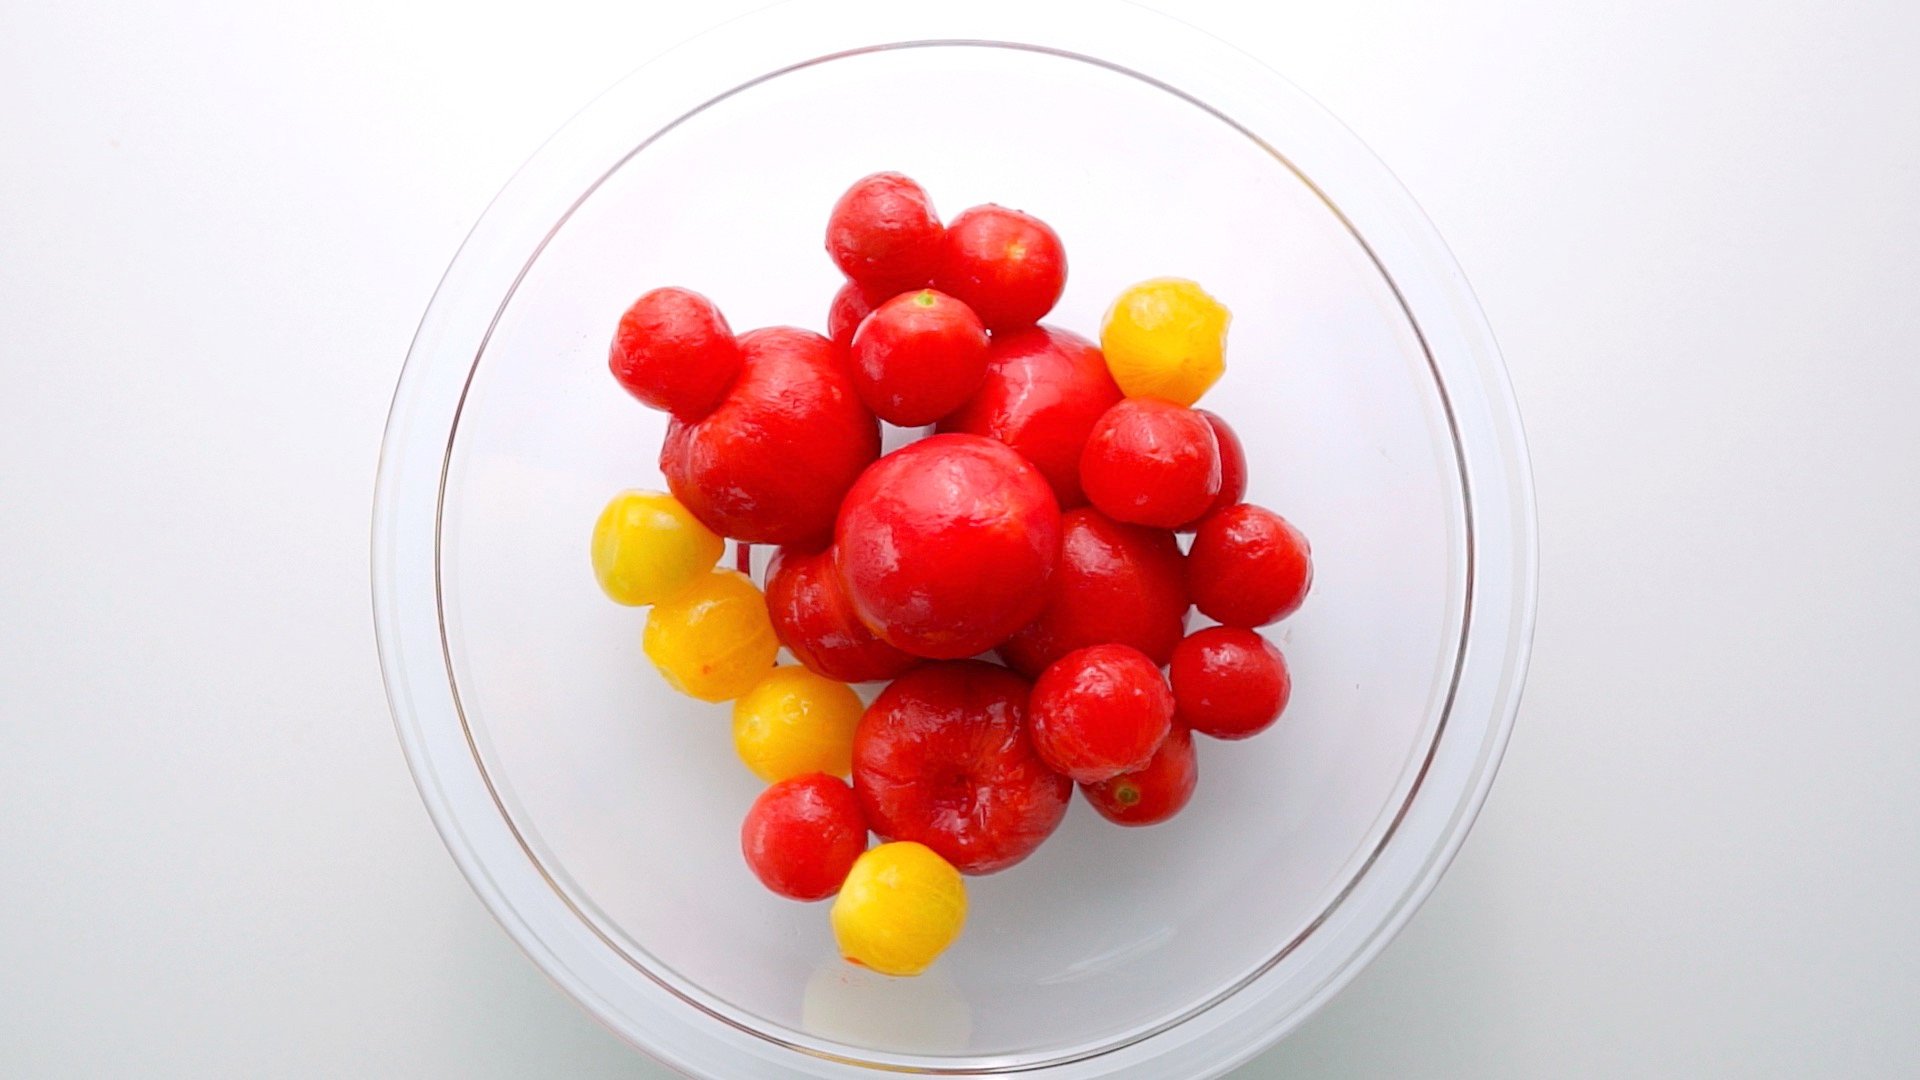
[0,0,1920,1080]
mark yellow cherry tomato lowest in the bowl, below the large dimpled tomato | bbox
[831,840,966,974]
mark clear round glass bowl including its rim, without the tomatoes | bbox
[372,0,1534,1080]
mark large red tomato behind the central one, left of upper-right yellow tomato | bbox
[939,327,1119,509]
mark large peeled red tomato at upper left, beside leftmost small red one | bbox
[660,327,879,544]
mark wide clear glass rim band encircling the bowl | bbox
[372,0,1538,1080]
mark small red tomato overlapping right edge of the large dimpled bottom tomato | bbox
[1027,646,1173,784]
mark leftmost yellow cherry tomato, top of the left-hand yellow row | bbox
[593,492,726,607]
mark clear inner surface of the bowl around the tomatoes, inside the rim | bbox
[440,44,1467,1065]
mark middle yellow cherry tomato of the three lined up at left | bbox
[641,571,780,701]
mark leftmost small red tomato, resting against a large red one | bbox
[607,288,741,421]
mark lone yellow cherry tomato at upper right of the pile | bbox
[1100,277,1233,405]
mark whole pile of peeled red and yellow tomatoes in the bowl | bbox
[593,173,1313,974]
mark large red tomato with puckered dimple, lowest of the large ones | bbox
[852,661,1073,874]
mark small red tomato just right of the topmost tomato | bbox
[933,206,1068,334]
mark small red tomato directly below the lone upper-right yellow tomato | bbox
[1081,398,1221,528]
